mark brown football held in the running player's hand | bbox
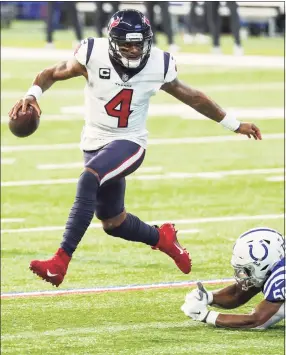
[9,105,40,137]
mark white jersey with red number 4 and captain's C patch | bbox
[74,38,177,150]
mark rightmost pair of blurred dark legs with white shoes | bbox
[206,1,243,55]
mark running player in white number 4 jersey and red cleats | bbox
[9,10,261,286]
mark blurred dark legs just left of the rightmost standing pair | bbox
[184,1,209,44]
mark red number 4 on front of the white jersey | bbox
[104,89,133,128]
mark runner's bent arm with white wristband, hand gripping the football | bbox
[9,59,88,119]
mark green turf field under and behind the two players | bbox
[1,26,284,355]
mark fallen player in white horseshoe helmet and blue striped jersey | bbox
[181,228,286,329]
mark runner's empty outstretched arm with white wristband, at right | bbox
[161,78,261,139]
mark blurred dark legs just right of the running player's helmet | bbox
[145,1,179,52]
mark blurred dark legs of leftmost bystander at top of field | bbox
[47,1,82,47]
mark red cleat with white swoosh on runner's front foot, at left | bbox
[30,248,71,287]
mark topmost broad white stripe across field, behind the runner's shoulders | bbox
[1,47,284,69]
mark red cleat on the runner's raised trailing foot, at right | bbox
[152,223,192,274]
